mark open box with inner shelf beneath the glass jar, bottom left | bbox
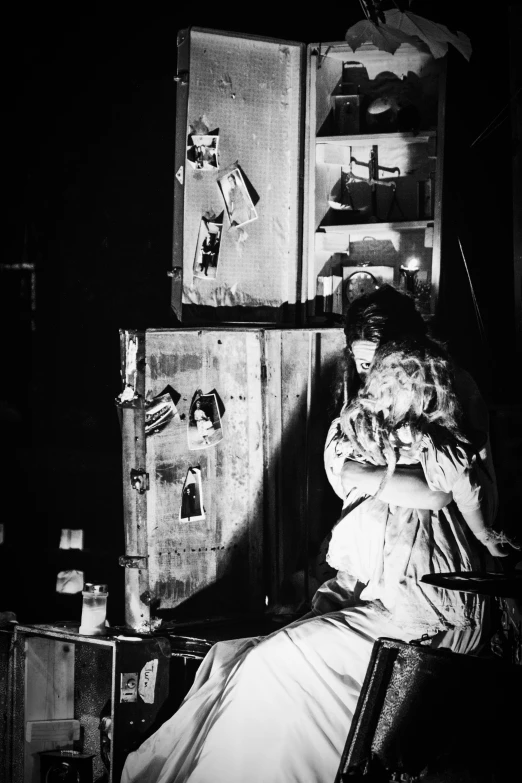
[10,623,172,783]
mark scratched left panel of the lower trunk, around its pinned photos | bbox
[145,330,263,616]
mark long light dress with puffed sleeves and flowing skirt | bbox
[122,421,492,783]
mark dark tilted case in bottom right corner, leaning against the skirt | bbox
[336,639,522,783]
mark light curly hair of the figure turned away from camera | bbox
[341,337,467,494]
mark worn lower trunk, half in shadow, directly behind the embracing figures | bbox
[119,326,344,629]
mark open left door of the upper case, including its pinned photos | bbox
[172,27,305,324]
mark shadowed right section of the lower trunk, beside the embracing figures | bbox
[266,329,345,603]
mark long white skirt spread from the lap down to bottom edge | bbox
[121,604,484,783]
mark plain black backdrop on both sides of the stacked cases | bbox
[0,0,522,623]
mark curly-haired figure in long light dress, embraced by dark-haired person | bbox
[122,290,505,783]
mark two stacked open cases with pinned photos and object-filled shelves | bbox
[121,27,445,628]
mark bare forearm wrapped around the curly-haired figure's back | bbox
[341,460,453,511]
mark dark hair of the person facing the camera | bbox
[344,285,427,350]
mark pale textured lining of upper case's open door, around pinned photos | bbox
[174,28,304,316]
